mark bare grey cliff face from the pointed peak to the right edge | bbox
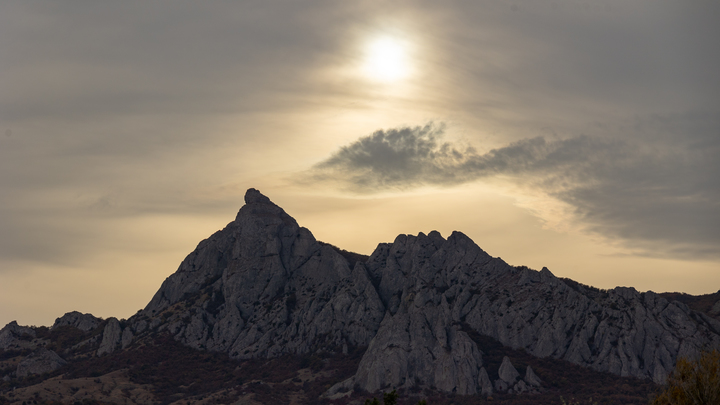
[124,189,720,394]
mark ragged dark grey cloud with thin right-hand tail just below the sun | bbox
[309,123,601,193]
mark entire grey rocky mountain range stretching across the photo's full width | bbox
[0,189,720,403]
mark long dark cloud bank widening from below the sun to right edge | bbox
[305,114,720,259]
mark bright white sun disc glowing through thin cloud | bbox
[363,37,410,82]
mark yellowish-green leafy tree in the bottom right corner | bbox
[652,349,720,405]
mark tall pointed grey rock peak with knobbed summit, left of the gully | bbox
[139,189,385,359]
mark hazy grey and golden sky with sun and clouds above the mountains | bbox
[0,0,720,325]
